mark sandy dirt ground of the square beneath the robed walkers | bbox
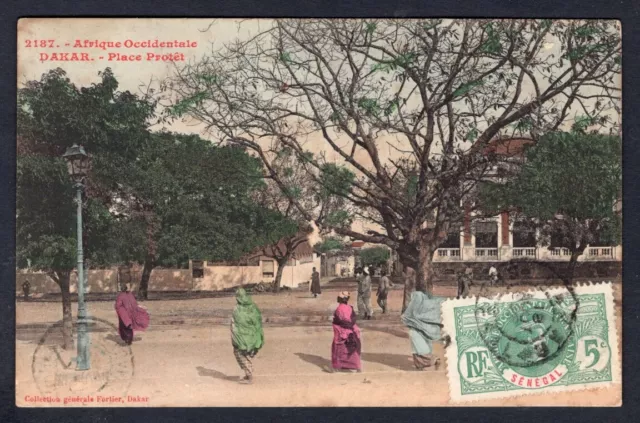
[16,287,622,407]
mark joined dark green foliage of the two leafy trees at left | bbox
[16,69,282,270]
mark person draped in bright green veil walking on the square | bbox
[231,288,264,383]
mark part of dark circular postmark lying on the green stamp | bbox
[475,286,579,377]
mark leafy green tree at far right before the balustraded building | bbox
[480,132,622,284]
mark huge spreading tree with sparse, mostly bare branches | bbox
[166,19,621,299]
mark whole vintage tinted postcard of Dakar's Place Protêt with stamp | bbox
[15,18,623,407]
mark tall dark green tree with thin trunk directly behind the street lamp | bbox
[16,69,153,348]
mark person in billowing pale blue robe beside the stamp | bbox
[402,291,442,370]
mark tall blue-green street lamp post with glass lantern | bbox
[62,144,91,370]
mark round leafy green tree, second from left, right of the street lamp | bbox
[112,133,278,298]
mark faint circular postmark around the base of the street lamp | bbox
[31,317,135,405]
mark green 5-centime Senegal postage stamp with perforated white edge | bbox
[442,283,621,402]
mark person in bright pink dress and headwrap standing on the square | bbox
[325,291,362,372]
